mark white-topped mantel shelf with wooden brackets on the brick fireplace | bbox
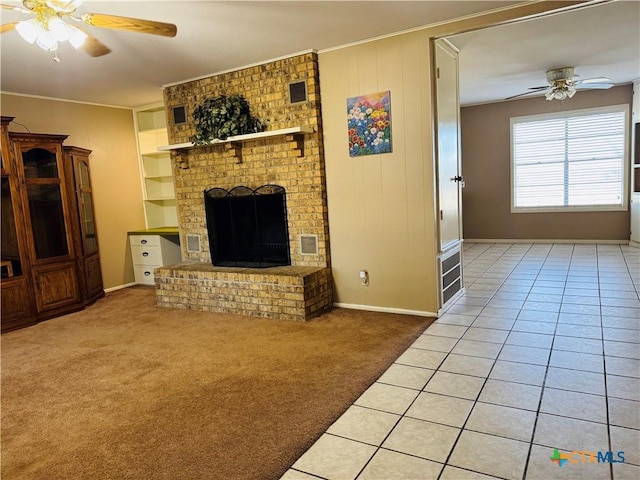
[158,127,314,168]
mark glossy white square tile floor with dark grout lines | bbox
[282,244,640,480]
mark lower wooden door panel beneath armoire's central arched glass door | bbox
[33,262,80,313]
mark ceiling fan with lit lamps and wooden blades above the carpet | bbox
[0,0,177,62]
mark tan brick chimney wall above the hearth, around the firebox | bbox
[164,53,330,267]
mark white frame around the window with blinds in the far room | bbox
[509,104,630,213]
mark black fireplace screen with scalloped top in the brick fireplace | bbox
[204,185,291,268]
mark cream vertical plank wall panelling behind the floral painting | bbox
[319,32,437,312]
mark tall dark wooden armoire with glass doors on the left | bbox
[0,117,104,332]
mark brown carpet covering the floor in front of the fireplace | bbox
[1,287,431,480]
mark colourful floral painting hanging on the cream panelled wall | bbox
[347,91,392,157]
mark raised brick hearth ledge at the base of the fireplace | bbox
[155,263,333,320]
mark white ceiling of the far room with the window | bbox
[449,0,640,105]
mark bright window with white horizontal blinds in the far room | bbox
[511,105,629,212]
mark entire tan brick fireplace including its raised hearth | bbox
[155,52,333,320]
